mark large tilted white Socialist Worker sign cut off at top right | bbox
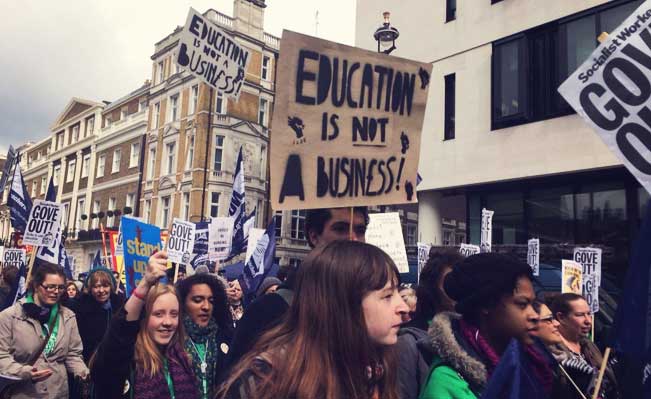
[558,1,651,192]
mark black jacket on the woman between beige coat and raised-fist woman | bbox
[70,293,124,364]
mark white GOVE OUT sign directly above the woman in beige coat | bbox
[23,200,63,247]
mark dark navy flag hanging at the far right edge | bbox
[610,201,651,399]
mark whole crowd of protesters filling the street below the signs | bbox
[0,207,623,399]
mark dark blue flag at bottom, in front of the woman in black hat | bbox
[481,339,548,399]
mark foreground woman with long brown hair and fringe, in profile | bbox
[218,241,408,399]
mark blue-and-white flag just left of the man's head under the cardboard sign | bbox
[240,216,276,302]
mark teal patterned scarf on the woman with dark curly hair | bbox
[183,314,219,399]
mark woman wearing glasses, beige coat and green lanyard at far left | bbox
[0,263,88,399]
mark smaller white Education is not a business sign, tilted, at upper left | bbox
[176,8,251,101]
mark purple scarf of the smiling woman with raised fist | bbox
[133,345,199,399]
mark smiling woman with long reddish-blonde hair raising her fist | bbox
[90,252,199,399]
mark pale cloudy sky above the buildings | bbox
[0,0,355,155]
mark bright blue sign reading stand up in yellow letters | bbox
[121,216,163,298]
